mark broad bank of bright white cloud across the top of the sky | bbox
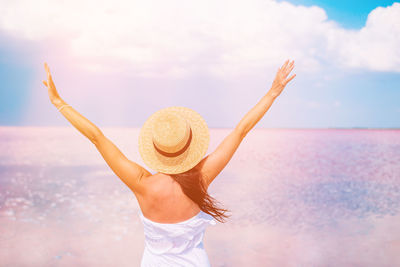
[0,0,400,78]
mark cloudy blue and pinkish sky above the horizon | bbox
[0,0,400,128]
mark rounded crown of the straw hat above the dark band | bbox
[152,113,190,153]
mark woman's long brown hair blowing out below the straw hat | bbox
[170,165,230,223]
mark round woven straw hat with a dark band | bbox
[139,106,210,174]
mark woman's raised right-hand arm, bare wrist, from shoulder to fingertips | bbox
[199,60,296,188]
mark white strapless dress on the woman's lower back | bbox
[138,208,217,267]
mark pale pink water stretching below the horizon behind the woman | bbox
[0,126,400,267]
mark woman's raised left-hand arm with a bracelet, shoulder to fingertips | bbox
[43,64,151,197]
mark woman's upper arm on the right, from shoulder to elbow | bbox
[199,128,245,187]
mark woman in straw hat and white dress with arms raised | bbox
[43,60,296,266]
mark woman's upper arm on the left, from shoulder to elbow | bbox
[93,133,151,194]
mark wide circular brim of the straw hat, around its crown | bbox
[139,106,210,174]
